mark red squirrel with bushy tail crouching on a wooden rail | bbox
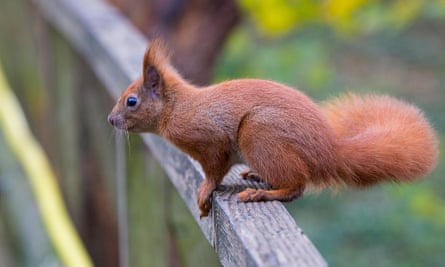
[108,39,438,220]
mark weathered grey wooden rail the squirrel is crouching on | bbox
[34,0,327,266]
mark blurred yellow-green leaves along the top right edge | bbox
[240,0,445,36]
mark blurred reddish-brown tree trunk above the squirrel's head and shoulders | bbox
[108,0,240,85]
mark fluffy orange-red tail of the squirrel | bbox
[323,94,438,186]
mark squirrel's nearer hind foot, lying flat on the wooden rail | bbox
[238,184,305,202]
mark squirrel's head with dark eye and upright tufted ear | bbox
[108,40,172,132]
